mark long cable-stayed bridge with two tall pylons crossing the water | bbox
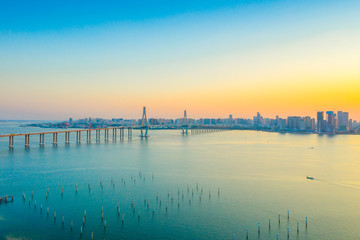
[0,107,228,149]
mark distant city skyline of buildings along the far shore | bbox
[32,111,360,134]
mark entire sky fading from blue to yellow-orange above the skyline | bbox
[0,0,360,120]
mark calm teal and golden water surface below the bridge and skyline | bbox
[0,123,360,239]
